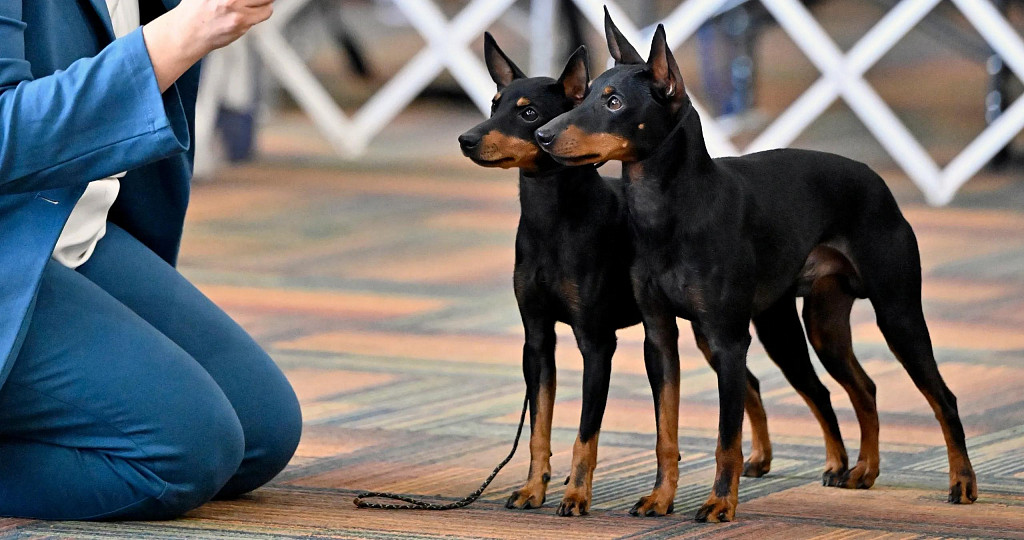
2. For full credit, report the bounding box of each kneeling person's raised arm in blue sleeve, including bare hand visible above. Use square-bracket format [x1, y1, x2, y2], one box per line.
[0, 0, 271, 195]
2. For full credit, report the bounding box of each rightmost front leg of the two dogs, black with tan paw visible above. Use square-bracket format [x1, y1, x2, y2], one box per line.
[694, 320, 751, 522]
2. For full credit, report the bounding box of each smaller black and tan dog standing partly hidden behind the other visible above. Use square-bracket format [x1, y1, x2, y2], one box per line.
[459, 34, 846, 515]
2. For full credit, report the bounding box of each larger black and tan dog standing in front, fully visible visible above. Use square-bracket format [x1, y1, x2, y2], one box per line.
[536, 11, 978, 521]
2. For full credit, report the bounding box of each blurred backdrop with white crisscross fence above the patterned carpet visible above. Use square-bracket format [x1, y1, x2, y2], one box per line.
[193, 0, 1024, 205]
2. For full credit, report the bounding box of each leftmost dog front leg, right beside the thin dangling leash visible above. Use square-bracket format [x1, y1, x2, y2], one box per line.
[505, 314, 555, 508]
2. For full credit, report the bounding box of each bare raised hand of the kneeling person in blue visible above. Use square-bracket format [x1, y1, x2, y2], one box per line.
[142, 0, 273, 92]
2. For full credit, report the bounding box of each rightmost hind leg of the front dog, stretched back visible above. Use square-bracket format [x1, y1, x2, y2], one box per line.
[858, 221, 978, 504]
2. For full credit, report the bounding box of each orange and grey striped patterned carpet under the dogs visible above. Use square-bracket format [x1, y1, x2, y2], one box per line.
[0, 158, 1024, 539]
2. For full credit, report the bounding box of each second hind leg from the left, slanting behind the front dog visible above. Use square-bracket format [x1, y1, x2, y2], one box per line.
[744, 295, 849, 485]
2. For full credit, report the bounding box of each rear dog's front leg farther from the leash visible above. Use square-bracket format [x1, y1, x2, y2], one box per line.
[558, 329, 615, 516]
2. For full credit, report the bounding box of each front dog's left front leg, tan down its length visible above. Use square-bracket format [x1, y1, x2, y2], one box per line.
[630, 311, 679, 515]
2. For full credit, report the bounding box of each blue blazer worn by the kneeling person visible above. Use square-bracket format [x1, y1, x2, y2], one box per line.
[0, 0, 199, 385]
